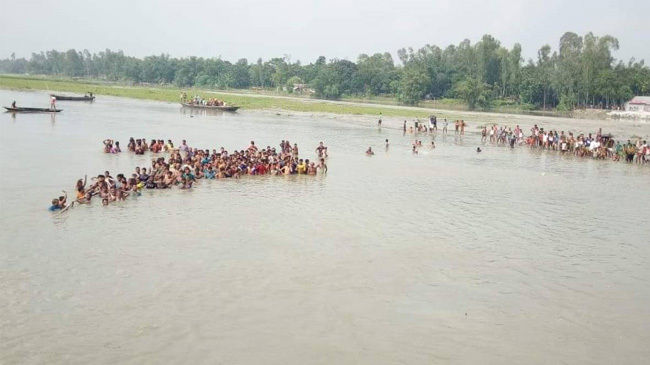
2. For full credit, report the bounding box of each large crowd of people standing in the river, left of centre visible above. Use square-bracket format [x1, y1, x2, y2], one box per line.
[50, 138, 328, 211]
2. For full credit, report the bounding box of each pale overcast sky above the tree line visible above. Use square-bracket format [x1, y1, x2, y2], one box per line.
[0, 0, 650, 63]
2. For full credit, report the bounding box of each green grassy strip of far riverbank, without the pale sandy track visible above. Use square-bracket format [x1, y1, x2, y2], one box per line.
[0, 75, 440, 118]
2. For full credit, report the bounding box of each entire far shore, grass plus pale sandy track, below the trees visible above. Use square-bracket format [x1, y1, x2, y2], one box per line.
[0, 75, 608, 120]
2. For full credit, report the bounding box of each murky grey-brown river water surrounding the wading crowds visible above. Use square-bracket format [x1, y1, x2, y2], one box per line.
[0, 91, 650, 364]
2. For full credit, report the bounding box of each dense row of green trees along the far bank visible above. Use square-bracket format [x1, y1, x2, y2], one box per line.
[0, 32, 650, 110]
